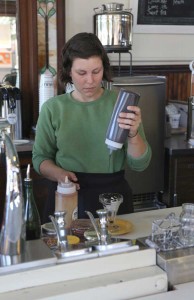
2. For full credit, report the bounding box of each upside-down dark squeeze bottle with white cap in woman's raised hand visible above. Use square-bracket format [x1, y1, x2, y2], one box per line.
[105, 89, 140, 154]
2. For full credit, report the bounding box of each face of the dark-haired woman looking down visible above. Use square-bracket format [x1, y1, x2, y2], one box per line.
[70, 56, 104, 101]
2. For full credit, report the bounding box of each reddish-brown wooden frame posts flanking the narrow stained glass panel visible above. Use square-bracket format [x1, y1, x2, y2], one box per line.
[17, 0, 65, 138]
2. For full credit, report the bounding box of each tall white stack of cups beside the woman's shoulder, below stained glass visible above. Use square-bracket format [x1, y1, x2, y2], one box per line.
[39, 69, 54, 112]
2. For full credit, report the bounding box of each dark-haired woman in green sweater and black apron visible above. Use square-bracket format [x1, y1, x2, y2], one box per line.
[33, 32, 151, 221]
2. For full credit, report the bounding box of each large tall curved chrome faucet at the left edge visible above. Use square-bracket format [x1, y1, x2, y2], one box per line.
[0, 132, 25, 258]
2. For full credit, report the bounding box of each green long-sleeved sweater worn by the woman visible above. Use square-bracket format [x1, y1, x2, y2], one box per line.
[33, 90, 151, 173]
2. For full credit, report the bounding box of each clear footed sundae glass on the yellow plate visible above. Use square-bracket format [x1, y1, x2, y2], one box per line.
[99, 193, 123, 232]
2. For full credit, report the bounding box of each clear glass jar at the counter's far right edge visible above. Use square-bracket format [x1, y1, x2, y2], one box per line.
[180, 203, 194, 247]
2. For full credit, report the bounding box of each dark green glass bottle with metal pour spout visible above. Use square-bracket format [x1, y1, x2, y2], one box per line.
[24, 164, 41, 241]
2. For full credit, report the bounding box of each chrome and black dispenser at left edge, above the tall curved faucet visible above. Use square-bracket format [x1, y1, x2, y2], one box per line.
[0, 83, 22, 140]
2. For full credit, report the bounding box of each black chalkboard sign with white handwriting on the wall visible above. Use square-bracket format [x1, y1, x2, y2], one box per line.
[137, 0, 194, 25]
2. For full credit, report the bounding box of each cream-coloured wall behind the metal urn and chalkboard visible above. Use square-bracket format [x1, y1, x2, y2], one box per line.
[66, 0, 194, 65]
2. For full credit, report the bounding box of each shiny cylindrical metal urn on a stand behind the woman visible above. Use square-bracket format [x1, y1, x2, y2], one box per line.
[94, 2, 133, 52]
